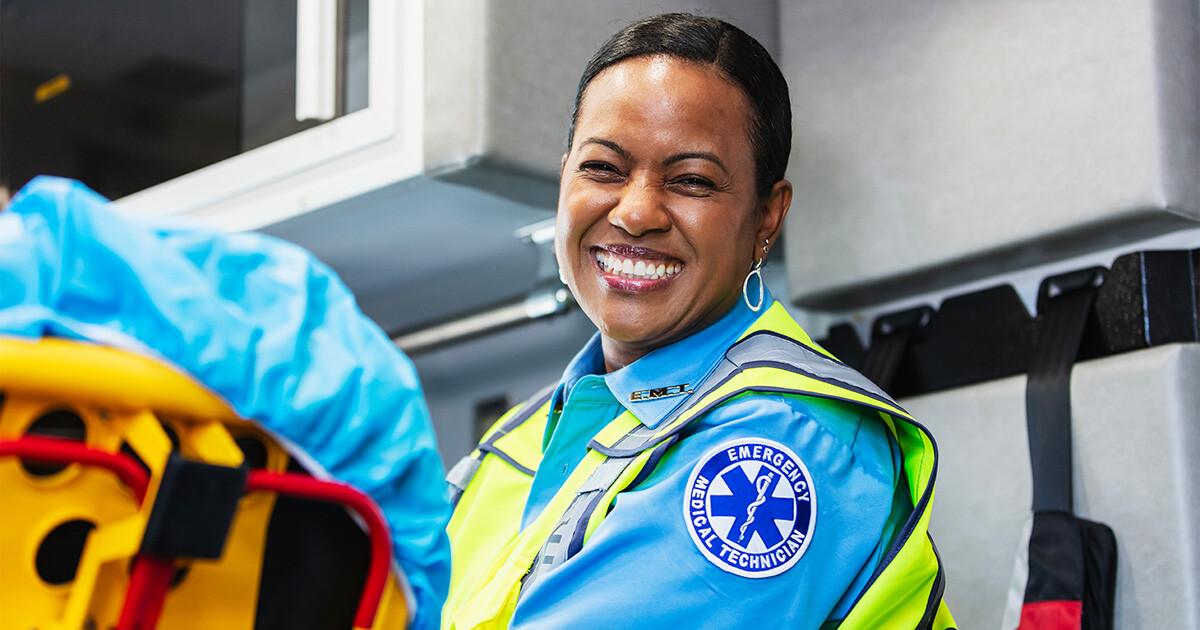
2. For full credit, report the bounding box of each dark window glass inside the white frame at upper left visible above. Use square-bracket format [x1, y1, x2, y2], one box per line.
[0, 0, 368, 198]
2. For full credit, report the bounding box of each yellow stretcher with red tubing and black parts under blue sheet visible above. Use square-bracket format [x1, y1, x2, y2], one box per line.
[0, 337, 408, 630]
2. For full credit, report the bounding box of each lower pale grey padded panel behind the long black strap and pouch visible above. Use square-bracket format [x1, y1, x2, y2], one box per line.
[900, 343, 1200, 630]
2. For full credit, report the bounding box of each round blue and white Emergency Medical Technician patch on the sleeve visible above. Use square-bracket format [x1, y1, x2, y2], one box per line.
[683, 438, 817, 577]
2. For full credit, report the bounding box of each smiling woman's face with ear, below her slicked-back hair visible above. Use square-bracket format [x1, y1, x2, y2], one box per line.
[554, 56, 791, 371]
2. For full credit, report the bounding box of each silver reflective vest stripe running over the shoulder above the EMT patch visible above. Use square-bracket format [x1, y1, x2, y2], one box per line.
[521, 331, 902, 595]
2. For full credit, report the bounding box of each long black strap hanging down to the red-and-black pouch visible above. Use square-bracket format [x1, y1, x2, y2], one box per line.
[1025, 268, 1104, 514]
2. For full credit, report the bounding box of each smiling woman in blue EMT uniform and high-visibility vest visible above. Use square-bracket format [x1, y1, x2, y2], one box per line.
[443, 14, 952, 629]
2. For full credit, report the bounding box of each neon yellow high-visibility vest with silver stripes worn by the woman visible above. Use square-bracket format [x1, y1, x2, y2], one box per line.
[442, 302, 954, 630]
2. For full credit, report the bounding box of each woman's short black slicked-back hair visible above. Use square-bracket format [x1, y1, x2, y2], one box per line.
[566, 13, 792, 197]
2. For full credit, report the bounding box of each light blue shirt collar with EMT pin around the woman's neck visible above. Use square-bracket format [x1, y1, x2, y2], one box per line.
[554, 292, 773, 428]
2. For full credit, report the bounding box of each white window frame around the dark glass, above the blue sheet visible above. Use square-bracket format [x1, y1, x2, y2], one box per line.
[114, 0, 425, 230]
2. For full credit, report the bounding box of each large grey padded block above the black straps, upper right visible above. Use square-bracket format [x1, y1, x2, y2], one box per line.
[780, 0, 1200, 310]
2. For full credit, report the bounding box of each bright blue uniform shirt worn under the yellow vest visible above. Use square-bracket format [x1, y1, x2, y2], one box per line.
[512, 296, 907, 630]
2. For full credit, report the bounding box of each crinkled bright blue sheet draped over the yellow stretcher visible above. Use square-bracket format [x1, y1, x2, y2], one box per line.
[0, 176, 450, 629]
